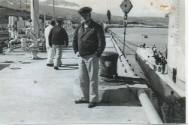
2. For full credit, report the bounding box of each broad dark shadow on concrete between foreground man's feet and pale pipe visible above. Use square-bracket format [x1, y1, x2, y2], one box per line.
[99, 88, 141, 106]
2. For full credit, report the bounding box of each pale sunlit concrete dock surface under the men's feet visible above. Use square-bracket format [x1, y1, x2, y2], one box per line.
[0, 40, 149, 125]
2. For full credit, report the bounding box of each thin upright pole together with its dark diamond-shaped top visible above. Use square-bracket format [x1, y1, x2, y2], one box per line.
[120, 0, 133, 54]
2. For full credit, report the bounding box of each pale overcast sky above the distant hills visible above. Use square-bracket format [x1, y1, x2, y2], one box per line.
[46, 0, 168, 17]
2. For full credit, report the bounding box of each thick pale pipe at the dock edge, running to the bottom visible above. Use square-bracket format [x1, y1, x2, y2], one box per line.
[137, 89, 163, 124]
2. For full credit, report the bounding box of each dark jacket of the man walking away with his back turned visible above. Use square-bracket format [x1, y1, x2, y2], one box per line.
[49, 26, 68, 46]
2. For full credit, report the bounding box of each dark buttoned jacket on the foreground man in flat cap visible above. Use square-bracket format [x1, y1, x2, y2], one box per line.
[73, 20, 106, 57]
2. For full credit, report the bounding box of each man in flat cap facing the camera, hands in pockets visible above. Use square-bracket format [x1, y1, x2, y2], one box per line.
[73, 7, 106, 108]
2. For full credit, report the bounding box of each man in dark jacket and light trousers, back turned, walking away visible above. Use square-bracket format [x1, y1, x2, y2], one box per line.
[49, 19, 68, 70]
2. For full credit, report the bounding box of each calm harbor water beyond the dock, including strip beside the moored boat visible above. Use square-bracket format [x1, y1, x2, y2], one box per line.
[111, 27, 168, 78]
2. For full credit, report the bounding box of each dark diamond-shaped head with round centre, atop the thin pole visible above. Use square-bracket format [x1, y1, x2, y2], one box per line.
[120, 0, 133, 14]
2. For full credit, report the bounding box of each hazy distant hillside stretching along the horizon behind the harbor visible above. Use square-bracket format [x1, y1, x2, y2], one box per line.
[0, 3, 168, 26]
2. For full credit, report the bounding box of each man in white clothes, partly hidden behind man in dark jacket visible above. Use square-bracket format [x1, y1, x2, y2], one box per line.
[44, 20, 56, 66]
